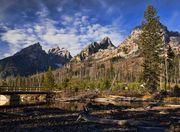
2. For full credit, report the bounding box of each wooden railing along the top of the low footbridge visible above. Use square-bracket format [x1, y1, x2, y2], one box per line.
[0, 86, 50, 92]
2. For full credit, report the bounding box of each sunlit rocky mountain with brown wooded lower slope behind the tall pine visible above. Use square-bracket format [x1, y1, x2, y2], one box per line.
[55, 25, 180, 82]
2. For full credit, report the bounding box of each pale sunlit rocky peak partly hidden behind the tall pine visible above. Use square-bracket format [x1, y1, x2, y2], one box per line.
[117, 25, 180, 57]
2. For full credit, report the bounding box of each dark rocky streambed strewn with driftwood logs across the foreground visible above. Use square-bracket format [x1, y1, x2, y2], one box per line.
[0, 91, 180, 132]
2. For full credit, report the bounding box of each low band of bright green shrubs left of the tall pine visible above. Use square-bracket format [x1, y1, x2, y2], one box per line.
[58, 78, 145, 94]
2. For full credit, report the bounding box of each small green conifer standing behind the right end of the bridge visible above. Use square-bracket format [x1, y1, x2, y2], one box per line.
[43, 67, 55, 89]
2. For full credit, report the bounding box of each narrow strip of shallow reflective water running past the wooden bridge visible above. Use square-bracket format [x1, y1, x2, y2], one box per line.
[0, 99, 149, 112]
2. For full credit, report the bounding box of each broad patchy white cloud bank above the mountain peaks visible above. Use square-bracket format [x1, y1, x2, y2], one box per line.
[1, 11, 123, 56]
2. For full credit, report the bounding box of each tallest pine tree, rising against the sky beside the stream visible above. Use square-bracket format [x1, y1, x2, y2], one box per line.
[139, 5, 164, 92]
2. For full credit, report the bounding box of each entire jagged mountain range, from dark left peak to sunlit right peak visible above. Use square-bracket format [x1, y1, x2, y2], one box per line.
[0, 25, 180, 78]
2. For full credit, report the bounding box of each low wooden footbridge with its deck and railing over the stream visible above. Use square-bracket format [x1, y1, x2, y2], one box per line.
[0, 86, 52, 95]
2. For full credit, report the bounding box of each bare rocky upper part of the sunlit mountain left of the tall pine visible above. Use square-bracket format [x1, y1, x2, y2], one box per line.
[71, 28, 141, 62]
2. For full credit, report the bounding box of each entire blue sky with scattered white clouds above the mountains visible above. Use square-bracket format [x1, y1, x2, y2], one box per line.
[0, 0, 180, 58]
